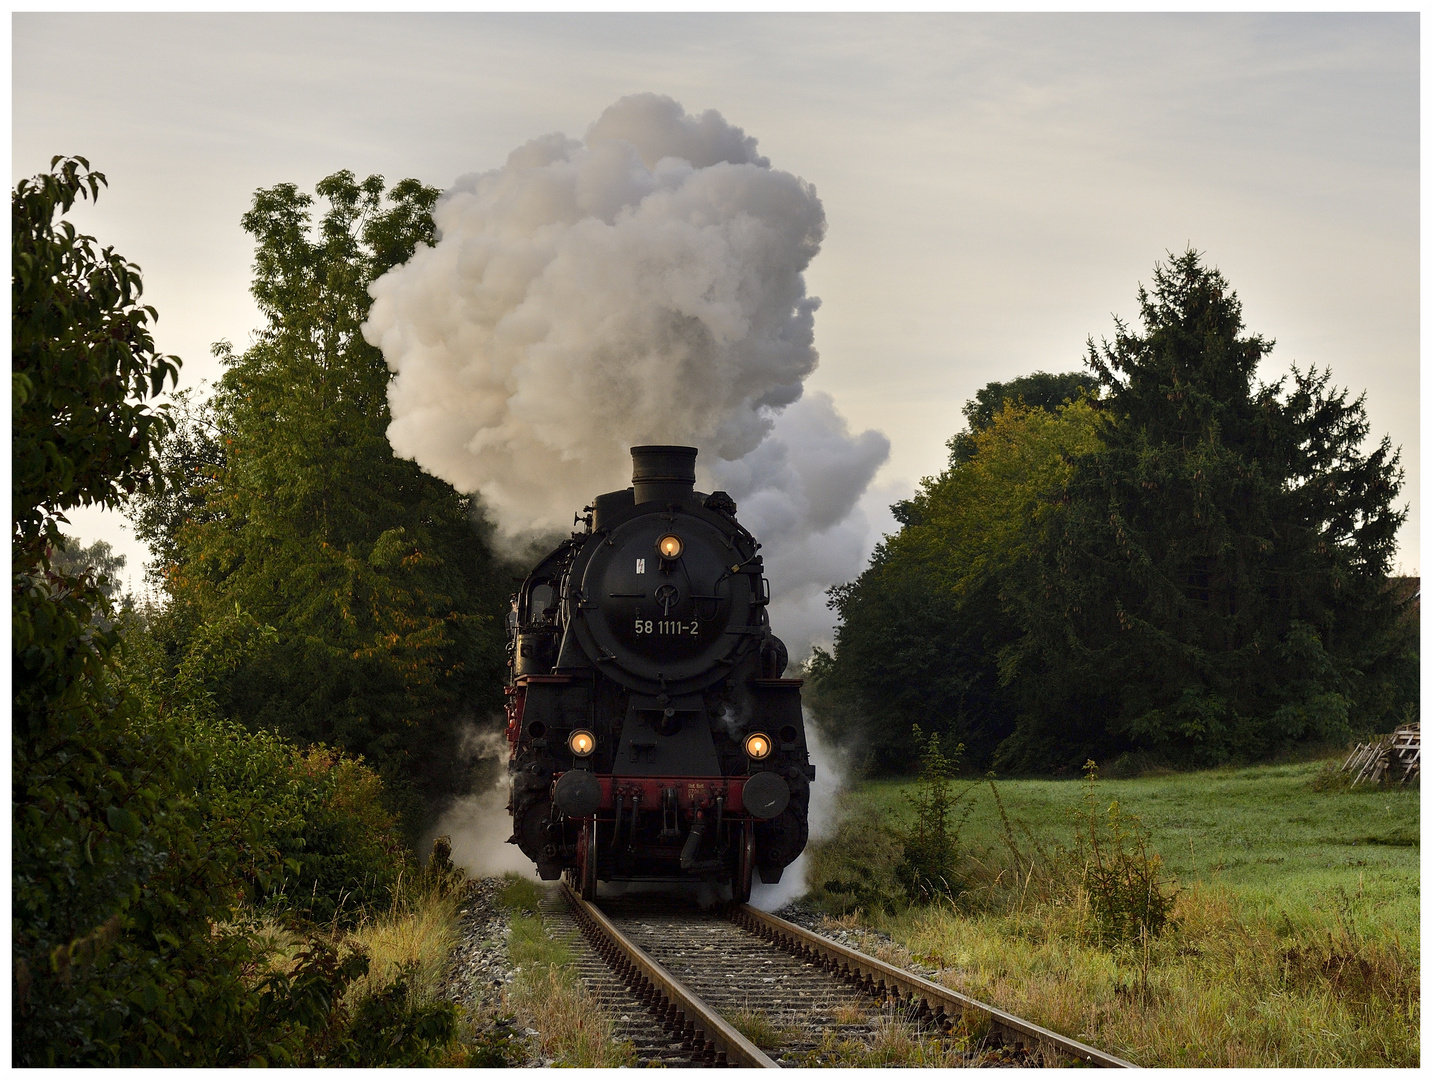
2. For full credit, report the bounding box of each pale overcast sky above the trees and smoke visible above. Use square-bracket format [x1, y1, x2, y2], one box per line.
[11, 14, 1421, 598]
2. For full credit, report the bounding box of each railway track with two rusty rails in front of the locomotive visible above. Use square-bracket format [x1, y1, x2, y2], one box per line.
[543, 884, 1133, 1069]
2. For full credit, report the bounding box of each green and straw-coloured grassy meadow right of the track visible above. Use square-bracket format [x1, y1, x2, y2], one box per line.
[808, 762, 1421, 1067]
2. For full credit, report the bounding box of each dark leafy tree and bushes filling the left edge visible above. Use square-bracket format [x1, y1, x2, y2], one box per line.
[11, 159, 454, 1067]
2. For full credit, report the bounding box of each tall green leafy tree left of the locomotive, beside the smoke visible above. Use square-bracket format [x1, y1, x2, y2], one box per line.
[136, 172, 510, 811]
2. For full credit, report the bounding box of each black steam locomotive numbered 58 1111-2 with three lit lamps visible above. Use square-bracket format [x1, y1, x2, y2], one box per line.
[505, 445, 815, 902]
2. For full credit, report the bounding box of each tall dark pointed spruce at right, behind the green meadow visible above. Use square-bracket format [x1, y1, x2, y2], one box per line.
[1001, 251, 1411, 768]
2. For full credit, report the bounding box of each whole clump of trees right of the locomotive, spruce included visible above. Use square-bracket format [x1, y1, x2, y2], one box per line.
[812, 251, 1418, 772]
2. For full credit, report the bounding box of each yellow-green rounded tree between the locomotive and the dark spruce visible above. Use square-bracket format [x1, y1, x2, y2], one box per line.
[812, 400, 1095, 772]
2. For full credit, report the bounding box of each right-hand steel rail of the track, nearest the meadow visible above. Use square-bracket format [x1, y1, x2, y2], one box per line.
[732, 904, 1138, 1069]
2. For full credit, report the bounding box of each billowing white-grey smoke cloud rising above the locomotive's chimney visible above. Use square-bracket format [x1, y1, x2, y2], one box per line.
[364, 95, 889, 657]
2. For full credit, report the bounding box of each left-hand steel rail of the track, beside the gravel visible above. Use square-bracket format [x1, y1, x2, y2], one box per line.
[561, 881, 780, 1069]
